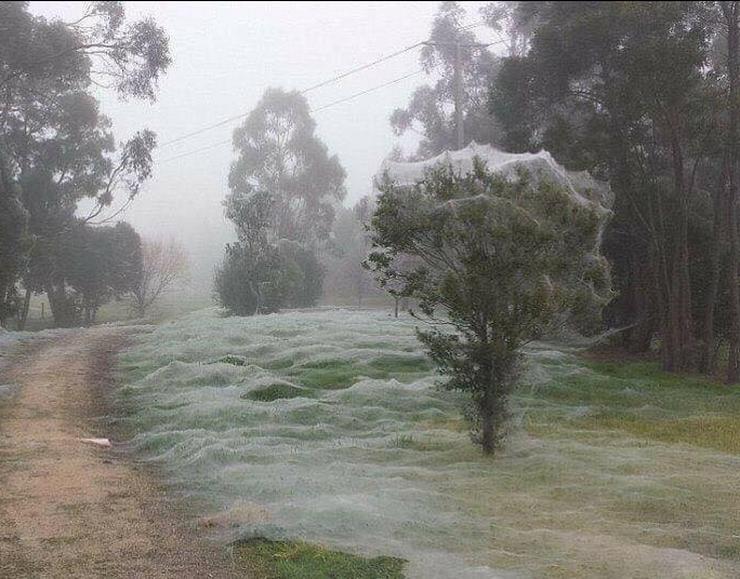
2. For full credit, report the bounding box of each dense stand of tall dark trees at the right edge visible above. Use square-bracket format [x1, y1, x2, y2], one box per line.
[491, 2, 740, 381]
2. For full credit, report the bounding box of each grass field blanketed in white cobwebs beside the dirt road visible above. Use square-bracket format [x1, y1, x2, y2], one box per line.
[119, 310, 740, 578]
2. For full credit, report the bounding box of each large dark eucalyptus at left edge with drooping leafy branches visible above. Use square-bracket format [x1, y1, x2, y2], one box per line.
[0, 2, 170, 325]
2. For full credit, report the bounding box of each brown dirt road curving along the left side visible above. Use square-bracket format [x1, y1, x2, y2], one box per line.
[0, 327, 235, 578]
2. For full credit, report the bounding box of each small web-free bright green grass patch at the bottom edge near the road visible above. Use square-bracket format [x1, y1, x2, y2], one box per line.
[233, 539, 405, 579]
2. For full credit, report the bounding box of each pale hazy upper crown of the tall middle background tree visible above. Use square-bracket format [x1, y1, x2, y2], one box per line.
[226, 89, 345, 244]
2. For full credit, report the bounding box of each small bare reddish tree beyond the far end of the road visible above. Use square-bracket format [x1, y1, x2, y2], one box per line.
[132, 239, 189, 316]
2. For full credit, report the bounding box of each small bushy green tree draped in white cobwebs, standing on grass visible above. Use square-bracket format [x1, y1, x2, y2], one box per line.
[368, 160, 610, 453]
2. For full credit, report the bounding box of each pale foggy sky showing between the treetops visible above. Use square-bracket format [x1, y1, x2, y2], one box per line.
[30, 2, 498, 285]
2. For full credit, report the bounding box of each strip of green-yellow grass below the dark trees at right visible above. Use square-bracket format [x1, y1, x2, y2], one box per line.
[528, 361, 740, 454]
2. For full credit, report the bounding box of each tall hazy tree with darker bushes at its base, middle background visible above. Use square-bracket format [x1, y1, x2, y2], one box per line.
[215, 89, 345, 315]
